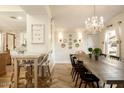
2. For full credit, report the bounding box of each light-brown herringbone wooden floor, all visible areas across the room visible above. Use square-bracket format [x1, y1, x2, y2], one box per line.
[0, 64, 118, 88]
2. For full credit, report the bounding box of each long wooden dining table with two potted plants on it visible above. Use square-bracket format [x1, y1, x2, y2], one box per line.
[77, 55, 124, 84]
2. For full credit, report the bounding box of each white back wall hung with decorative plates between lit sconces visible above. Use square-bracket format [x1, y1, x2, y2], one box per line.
[54, 30, 98, 63]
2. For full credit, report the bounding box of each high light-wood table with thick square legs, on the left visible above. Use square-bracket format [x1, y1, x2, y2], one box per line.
[11, 53, 41, 88]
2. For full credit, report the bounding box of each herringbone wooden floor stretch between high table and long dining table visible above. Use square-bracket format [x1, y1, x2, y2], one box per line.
[50, 64, 74, 88]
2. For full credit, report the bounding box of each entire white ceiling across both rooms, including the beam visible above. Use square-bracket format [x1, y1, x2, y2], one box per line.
[0, 5, 124, 31]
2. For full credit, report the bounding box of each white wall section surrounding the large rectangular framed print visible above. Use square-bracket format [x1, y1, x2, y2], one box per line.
[27, 14, 50, 53]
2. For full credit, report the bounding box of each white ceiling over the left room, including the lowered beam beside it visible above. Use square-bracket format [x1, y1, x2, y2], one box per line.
[0, 5, 48, 32]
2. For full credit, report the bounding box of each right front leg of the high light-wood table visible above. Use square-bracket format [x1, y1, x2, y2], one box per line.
[34, 59, 38, 88]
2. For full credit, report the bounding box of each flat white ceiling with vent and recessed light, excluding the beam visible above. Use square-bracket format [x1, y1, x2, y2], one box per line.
[0, 12, 26, 32]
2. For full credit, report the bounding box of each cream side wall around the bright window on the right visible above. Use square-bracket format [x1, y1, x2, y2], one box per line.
[99, 13, 124, 59]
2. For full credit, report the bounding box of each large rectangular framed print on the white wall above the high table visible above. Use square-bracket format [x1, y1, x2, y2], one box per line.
[31, 24, 45, 44]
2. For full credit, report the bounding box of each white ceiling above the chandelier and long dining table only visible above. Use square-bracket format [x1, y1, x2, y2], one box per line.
[50, 5, 124, 30]
